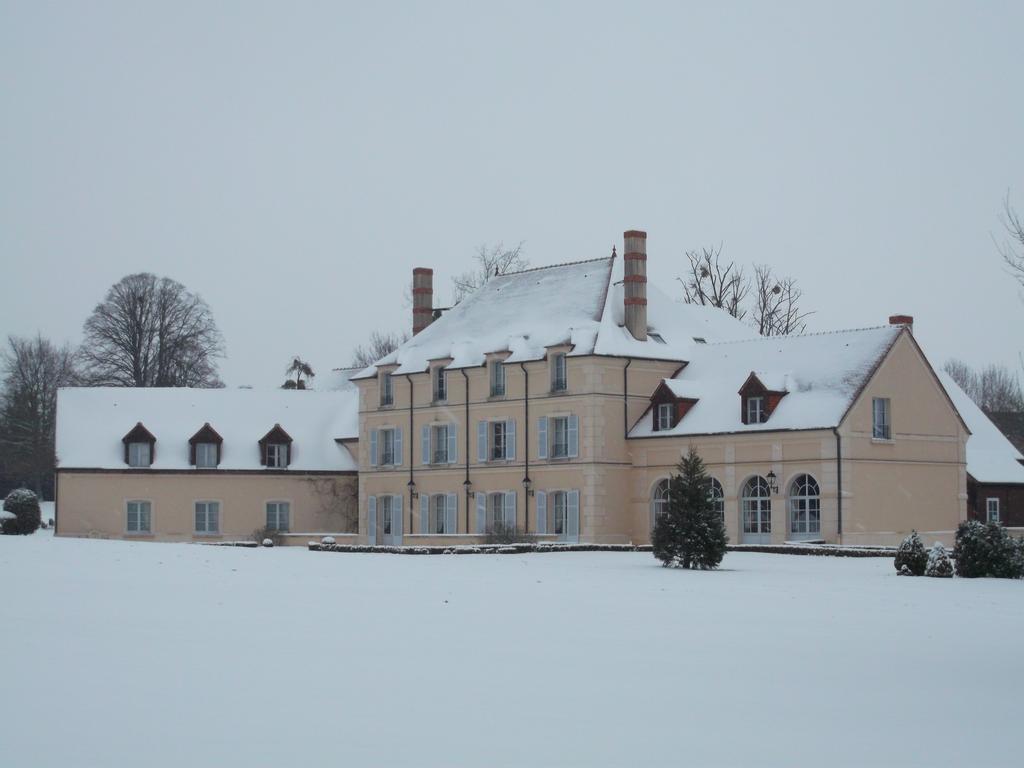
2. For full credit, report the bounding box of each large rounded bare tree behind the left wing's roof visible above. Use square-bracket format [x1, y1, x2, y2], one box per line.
[80, 272, 224, 387]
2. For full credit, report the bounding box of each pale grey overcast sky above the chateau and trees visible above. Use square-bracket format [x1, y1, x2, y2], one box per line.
[0, 0, 1024, 386]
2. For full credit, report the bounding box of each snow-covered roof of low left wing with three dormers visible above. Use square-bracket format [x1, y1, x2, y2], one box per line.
[56, 387, 358, 471]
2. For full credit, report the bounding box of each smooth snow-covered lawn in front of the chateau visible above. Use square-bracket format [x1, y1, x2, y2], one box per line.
[0, 531, 1024, 768]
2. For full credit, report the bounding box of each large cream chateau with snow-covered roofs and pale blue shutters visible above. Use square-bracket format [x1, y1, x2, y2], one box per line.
[57, 230, 1024, 546]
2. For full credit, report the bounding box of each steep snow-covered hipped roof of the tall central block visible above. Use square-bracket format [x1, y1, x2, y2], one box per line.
[353, 257, 754, 379]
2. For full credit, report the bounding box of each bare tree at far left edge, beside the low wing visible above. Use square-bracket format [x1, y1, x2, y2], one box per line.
[0, 335, 78, 498]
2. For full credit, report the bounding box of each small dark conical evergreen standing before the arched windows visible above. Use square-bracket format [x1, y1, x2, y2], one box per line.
[651, 446, 729, 570]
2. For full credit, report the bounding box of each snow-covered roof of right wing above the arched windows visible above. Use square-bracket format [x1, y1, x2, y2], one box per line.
[630, 326, 901, 437]
